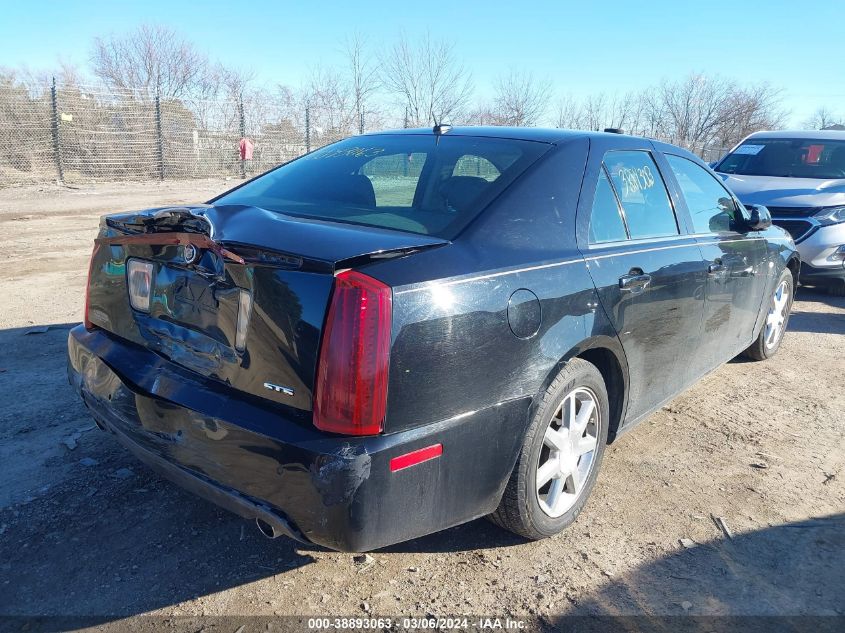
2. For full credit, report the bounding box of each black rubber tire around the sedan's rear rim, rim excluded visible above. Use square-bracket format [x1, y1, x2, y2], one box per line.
[489, 358, 610, 540]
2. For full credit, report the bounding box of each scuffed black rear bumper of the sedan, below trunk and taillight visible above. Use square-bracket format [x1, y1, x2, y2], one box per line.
[68, 326, 528, 551]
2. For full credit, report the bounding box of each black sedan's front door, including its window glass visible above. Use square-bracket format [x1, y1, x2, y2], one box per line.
[664, 153, 767, 374]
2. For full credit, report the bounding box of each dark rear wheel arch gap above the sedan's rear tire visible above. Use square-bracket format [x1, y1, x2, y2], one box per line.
[529, 336, 628, 444]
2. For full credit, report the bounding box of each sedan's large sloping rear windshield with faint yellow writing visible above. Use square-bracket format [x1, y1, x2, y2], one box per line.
[214, 134, 550, 239]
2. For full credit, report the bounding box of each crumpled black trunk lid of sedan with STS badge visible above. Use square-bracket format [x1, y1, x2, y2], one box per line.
[87, 205, 447, 421]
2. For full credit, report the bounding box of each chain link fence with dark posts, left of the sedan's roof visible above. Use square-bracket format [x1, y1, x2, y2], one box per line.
[0, 80, 354, 187]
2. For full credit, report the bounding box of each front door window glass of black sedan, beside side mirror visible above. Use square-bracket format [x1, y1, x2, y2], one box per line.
[666, 154, 741, 233]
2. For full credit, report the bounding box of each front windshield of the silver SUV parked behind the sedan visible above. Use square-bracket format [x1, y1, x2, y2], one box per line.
[716, 138, 845, 179]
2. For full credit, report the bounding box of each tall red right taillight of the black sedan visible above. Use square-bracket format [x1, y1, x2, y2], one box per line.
[314, 270, 393, 435]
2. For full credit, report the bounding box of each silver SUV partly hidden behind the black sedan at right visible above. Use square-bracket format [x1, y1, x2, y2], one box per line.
[713, 130, 845, 296]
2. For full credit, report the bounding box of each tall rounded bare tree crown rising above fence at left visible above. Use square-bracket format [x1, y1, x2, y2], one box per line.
[91, 25, 213, 98]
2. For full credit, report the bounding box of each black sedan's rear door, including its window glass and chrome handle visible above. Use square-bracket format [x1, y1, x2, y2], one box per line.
[578, 138, 706, 420]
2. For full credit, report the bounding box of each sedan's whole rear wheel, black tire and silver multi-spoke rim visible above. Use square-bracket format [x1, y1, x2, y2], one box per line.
[490, 358, 609, 539]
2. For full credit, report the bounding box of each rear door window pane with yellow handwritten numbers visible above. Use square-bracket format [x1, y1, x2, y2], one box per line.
[604, 151, 678, 239]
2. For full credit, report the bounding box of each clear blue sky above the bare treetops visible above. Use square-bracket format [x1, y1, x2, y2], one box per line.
[0, 0, 845, 125]
